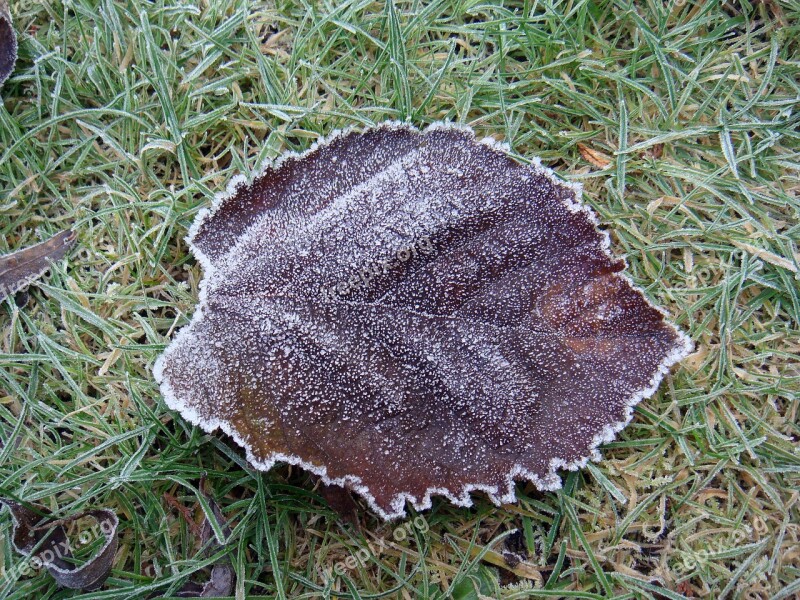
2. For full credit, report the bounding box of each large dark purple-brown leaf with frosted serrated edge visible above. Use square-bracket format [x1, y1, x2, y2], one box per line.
[155, 123, 691, 518]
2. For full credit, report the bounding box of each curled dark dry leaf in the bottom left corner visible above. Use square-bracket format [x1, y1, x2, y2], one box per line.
[0, 498, 119, 591]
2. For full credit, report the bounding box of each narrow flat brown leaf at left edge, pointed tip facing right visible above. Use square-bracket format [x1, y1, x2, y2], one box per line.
[0, 229, 75, 300]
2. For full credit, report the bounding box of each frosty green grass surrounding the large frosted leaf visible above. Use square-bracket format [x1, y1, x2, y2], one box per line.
[0, 0, 800, 600]
